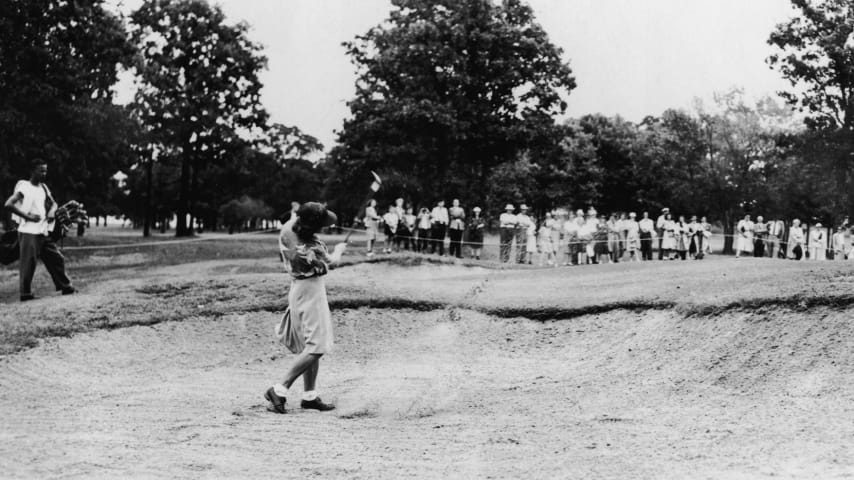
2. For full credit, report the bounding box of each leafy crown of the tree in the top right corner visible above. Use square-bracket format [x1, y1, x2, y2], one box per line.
[768, 0, 854, 131]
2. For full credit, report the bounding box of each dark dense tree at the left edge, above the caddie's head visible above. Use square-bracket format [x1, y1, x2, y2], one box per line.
[0, 0, 137, 221]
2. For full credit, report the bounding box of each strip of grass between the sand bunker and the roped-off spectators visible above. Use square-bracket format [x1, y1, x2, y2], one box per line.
[0, 226, 854, 354]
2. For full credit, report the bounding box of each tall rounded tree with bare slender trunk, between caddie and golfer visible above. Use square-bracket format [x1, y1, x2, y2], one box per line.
[131, 0, 267, 236]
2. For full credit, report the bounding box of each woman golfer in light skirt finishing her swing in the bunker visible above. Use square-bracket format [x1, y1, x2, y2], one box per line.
[264, 202, 346, 413]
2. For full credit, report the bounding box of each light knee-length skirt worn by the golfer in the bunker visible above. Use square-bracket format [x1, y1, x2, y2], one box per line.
[276, 276, 333, 353]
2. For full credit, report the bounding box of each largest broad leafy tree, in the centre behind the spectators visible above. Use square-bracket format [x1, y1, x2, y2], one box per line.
[327, 0, 575, 221]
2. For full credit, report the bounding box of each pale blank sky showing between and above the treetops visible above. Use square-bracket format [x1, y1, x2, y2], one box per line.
[110, 0, 794, 149]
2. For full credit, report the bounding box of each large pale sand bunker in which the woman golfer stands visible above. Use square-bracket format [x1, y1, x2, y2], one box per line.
[0, 306, 854, 478]
